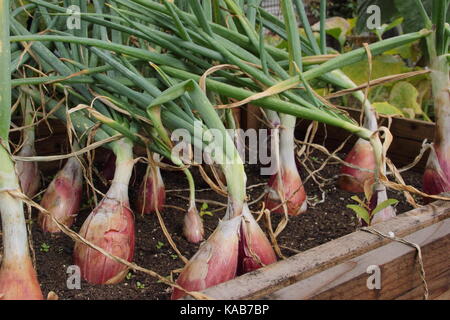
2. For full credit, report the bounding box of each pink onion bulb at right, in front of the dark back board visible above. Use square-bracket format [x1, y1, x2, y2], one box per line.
[338, 139, 376, 193]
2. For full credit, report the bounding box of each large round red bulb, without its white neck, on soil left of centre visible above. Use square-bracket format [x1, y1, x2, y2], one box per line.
[74, 194, 135, 284]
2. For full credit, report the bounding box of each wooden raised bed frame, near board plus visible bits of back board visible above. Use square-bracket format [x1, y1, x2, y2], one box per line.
[196, 109, 450, 300]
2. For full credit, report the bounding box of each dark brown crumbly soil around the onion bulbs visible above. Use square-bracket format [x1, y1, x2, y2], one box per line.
[7, 150, 421, 300]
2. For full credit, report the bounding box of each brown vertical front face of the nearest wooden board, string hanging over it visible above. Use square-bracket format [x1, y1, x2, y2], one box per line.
[264, 219, 450, 300]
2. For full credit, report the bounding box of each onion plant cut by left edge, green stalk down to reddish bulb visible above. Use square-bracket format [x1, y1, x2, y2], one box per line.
[0, 0, 43, 300]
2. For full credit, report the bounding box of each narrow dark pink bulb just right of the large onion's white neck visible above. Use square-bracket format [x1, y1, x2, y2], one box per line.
[137, 169, 166, 214]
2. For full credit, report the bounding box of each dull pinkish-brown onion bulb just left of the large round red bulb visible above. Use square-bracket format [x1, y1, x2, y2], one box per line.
[38, 158, 83, 233]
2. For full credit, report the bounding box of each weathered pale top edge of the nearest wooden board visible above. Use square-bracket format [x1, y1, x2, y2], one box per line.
[198, 201, 450, 300]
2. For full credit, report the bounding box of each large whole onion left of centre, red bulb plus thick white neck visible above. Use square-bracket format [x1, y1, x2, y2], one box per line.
[74, 139, 135, 284]
